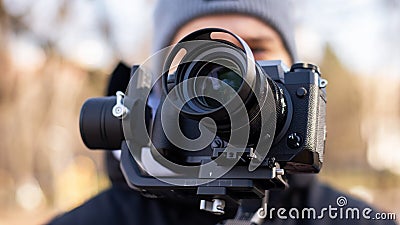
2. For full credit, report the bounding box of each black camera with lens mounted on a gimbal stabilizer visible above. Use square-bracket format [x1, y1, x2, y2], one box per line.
[80, 28, 327, 214]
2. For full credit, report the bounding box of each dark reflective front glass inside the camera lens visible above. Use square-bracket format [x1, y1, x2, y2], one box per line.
[194, 63, 243, 109]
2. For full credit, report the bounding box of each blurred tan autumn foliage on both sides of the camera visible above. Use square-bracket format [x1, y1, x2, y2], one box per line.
[0, 0, 400, 224]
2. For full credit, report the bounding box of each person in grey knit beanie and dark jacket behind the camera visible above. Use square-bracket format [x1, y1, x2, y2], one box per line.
[50, 0, 394, 225]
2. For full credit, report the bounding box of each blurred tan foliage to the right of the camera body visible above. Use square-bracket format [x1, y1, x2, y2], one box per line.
[319, 45, 400, 215]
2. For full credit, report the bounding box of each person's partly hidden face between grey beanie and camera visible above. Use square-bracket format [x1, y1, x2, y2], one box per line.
[172, 14, 292, 66]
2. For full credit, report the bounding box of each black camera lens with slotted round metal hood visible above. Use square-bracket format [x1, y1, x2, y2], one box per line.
[163, 29, 287, 146]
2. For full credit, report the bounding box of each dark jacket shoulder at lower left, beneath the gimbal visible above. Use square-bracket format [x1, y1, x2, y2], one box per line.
[49, 185, 225, 225]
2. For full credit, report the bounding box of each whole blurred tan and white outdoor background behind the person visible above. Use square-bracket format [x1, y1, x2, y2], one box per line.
[0, 0, 400, 225]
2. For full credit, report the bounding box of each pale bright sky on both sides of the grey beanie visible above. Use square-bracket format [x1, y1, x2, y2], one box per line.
[3, 0, 400, 79]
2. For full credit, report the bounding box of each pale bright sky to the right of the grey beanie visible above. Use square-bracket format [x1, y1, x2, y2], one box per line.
[295, 0, 400, 78]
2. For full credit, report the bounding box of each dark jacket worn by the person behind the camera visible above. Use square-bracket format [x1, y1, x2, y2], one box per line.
[50, 153, 395, 225]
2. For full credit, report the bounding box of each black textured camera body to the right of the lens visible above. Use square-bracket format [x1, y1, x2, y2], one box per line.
[253, 61, 327, 173]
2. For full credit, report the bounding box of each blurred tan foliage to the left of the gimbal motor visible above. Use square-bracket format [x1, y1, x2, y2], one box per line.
[0, 2, 109, 221]
